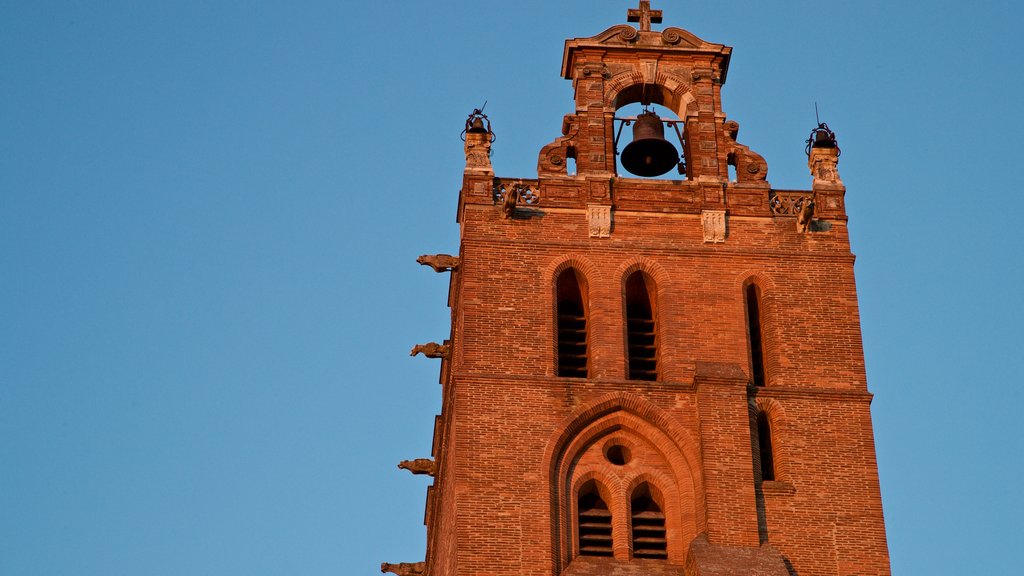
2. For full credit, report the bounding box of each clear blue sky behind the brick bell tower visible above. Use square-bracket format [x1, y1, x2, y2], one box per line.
[0, 0, 1024, 576]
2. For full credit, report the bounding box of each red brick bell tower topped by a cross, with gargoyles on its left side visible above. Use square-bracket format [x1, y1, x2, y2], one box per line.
[382, 1, 890, 576]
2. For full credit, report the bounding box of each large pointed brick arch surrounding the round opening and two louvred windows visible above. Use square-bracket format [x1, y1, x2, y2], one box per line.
[542, 392, 707, 574]
